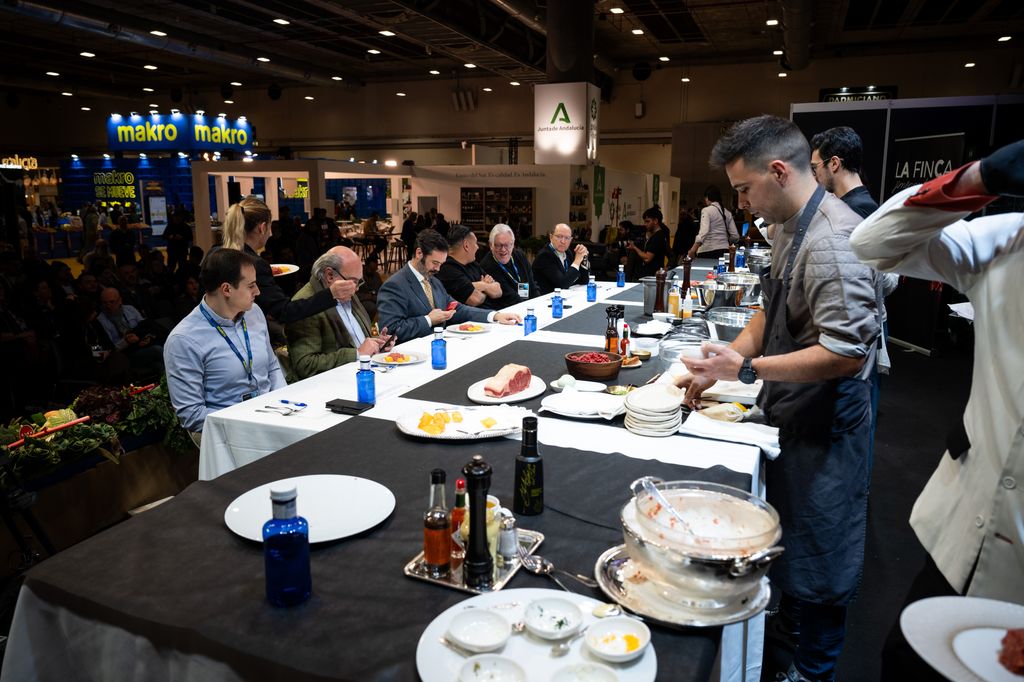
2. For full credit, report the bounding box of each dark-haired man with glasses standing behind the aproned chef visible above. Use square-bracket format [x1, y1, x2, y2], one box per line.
[811, 126, 879, 218]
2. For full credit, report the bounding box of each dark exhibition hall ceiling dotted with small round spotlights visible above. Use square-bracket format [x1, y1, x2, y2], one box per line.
[0, 0, 1024, 106]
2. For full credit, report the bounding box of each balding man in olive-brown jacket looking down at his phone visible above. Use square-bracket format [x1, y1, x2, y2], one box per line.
[285, 246, 393, 379]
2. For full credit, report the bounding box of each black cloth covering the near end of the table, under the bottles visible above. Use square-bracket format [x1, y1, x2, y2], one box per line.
[26, 417, 751, 681]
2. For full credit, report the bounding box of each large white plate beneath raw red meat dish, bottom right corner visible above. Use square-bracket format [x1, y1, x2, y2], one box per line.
[899, 597, 1024, 682]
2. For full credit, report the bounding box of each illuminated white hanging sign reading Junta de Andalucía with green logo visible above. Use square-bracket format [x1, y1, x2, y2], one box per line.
[534, 83, 601, 164]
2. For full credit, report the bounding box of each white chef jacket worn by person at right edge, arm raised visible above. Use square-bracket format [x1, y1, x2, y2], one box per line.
[850, 185, 1024, 604]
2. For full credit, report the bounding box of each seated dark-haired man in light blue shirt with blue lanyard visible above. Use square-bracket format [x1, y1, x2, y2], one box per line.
[164, 249, 285, 433]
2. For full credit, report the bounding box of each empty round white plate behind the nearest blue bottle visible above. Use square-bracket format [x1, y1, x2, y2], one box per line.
[224, 474, 394, 544]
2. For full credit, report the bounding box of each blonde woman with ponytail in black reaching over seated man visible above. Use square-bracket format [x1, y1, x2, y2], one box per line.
[222, 196, 358, 325]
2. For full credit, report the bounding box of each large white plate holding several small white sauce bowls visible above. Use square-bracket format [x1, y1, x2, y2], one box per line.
[416, 588, 657, 682]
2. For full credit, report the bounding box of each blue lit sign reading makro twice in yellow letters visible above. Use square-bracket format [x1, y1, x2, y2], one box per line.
[106, 114, 253, 152]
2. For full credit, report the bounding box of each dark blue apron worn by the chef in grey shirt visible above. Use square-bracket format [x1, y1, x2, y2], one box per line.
[758, 186, 871, 604]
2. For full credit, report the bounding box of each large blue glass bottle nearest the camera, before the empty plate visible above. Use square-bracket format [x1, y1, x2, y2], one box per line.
[263, 486, 313, 606]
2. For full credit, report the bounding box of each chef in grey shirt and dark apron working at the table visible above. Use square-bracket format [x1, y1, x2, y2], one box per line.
[677, 116, 879, 682]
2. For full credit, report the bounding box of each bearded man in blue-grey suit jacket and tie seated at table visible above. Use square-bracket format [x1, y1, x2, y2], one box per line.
[377, 229, 522, 341]
